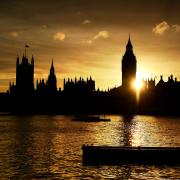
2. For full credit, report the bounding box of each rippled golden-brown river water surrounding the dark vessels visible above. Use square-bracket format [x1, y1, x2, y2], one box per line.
[0, 115, 180, 179]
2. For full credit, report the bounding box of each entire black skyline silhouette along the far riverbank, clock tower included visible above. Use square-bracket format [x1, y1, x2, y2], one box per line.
[3, 37, 180, 113]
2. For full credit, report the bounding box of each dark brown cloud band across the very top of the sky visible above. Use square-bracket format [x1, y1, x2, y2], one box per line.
[0, 0, 180, 26]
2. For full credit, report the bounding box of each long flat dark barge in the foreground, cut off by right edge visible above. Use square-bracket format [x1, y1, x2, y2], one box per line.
[82, 145, 180, 165]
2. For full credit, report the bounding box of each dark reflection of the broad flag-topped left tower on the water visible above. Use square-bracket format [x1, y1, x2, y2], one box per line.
[11, 117, 32, 174]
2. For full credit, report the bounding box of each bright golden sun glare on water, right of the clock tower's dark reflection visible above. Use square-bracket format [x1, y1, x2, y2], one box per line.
[132, 116, 180, 146]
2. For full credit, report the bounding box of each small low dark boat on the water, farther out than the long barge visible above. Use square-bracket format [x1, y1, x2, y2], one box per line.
[72, 116, 111, 122]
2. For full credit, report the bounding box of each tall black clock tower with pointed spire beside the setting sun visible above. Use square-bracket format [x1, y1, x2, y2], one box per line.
[122, 37, 136, 88]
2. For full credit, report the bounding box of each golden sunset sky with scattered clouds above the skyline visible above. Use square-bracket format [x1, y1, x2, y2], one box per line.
[0, 0, 180, 92]
